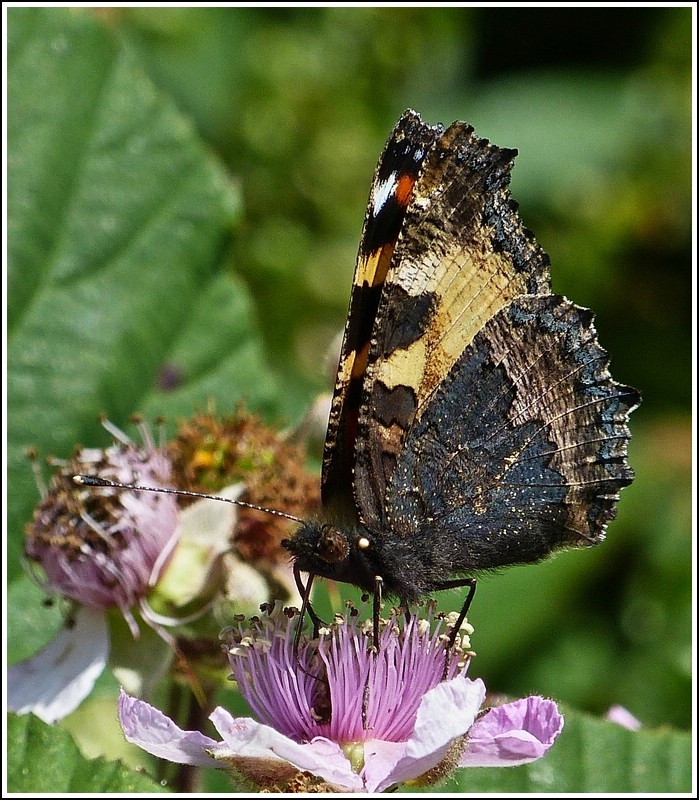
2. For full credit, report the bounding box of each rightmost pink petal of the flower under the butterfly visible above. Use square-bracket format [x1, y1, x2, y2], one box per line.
[459, 697, 563, 767]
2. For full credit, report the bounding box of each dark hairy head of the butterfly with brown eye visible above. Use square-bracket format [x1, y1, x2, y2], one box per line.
[282, 520, 376, 591]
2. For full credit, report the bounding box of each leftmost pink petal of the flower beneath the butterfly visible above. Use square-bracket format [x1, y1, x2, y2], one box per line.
[118, 691, 220, 767]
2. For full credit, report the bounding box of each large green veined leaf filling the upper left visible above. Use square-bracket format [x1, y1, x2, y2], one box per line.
[7, 8, 274, 577]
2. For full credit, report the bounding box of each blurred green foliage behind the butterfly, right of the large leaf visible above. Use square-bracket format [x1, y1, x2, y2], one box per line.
[10, 1, 692, 768]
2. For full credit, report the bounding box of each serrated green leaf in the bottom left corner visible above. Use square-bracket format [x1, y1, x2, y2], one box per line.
[7, 714, 165, 795]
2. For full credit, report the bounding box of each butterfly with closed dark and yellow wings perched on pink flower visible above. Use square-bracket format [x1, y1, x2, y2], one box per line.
[282, 110, 640, 627]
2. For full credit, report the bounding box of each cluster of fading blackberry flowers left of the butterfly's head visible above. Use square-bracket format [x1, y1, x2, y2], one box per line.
[8, 411, 314, 722]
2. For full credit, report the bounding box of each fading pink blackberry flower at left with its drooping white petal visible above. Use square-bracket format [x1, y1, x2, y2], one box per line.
[7, 422, 179, 723]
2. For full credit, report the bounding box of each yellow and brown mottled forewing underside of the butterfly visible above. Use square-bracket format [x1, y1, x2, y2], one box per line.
[354, 122, 550, 529]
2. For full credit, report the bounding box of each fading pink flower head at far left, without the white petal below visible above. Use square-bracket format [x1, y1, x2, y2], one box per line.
[25, 418, 178, 636]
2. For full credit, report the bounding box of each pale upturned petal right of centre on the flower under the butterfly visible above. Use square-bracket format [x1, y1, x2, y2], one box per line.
[362, 673, 485, 792]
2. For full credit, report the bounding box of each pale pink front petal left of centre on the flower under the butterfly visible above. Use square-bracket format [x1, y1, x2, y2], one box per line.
[210, 707, 364, 791]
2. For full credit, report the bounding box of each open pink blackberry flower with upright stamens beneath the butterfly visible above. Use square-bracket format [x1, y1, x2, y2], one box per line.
[119, 604, 563, 792]
